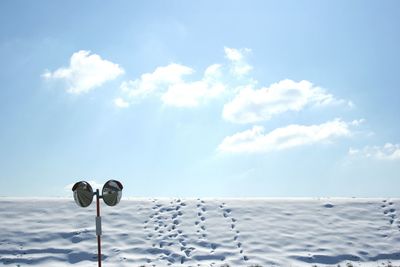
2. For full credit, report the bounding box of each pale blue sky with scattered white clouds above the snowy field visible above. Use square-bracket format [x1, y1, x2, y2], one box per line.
[0, 1, 400, 197]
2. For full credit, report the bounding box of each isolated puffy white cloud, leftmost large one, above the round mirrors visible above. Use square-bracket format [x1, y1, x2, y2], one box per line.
[42, 50, 124, 94]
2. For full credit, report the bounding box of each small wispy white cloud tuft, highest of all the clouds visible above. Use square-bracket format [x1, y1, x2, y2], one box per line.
[224, 47, 253, 76]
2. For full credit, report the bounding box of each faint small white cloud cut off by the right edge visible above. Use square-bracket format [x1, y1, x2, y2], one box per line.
[348, 143, 400, 160]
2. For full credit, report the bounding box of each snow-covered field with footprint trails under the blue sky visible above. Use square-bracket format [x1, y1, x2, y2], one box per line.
[0, 198, 400, 267]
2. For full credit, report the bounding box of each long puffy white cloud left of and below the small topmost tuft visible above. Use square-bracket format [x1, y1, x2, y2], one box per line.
[121, 64, 225, 107]
